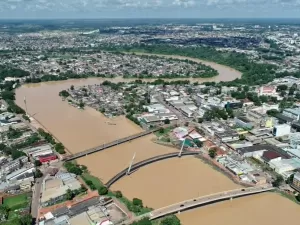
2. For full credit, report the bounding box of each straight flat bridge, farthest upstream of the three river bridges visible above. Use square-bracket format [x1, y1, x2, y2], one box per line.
[64, 127, 160, 161]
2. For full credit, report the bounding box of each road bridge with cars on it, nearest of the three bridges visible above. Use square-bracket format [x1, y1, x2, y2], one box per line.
[146, 185, 275, 220]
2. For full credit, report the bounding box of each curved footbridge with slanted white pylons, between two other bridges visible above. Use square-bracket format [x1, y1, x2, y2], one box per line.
[105, 151, 199, 188]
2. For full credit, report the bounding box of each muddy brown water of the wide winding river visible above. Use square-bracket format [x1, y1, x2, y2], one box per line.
[16, 57, 300, 225]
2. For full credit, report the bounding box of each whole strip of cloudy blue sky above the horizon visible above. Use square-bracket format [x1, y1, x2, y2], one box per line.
[0, 0, 300, 18]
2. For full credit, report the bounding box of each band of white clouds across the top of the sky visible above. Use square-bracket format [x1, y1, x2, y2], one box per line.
[0, 0, 300, 12]
